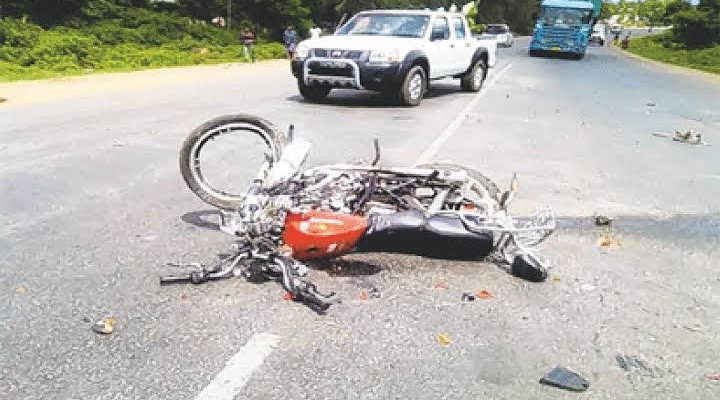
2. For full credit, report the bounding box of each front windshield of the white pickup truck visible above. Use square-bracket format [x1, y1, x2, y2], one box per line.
[337, 14, 430, 38]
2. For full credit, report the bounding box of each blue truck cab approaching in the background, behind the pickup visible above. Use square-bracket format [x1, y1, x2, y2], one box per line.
[528, 0, 599, 59]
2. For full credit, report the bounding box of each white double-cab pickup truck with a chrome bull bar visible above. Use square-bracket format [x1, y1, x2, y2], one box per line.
[292, 10, 496, 106]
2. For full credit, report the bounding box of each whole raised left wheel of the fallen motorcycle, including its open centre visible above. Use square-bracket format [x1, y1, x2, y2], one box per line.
[179, 114, 285, 210]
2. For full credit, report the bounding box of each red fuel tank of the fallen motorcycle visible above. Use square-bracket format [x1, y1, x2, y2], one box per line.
[282, 211, 367, 260]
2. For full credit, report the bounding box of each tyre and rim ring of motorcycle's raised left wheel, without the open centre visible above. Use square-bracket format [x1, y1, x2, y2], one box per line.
[179, 114, 285, 210]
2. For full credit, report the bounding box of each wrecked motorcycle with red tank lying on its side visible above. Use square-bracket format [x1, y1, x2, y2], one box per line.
[161, 115, 556, 311]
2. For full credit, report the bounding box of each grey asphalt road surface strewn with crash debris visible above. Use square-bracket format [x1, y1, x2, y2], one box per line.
[0, 40, 720, 400]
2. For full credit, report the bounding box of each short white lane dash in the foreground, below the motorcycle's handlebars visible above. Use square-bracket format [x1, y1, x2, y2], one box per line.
[195, 333, 280, 400]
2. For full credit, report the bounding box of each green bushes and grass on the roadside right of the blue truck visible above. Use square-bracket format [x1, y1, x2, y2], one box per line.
[603, 0, 720, 74]
